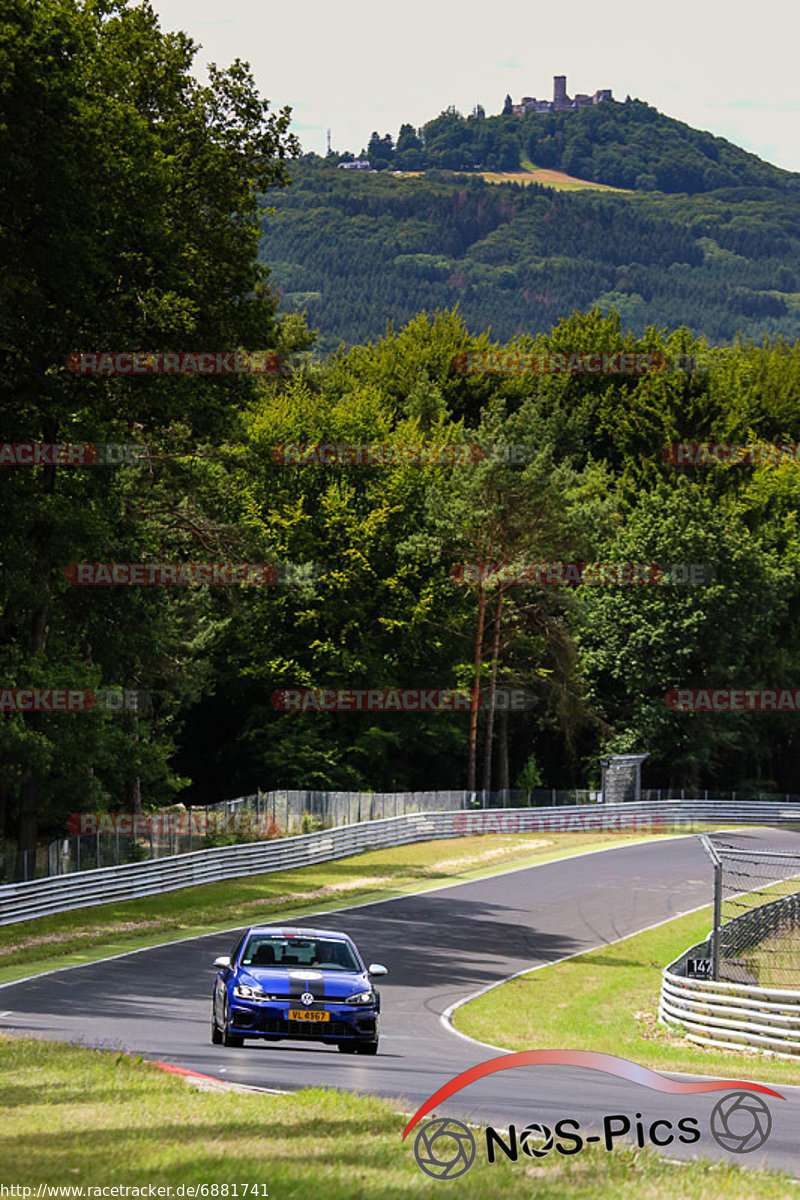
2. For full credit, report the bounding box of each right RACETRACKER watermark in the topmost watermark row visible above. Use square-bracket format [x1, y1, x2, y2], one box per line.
[452, 350, 706, 376]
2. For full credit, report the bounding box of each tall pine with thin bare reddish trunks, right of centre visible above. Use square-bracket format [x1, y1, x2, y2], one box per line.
[432, 384, 603, 791]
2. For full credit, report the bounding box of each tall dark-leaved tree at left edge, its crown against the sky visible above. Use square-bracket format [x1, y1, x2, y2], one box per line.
[0, 0, 299, 868]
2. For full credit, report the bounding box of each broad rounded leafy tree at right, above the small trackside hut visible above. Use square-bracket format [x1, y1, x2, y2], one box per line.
[577, 478, 796, 787]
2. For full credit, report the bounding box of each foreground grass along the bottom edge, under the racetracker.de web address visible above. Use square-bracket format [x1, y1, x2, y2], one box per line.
[0, 1038, 794, 1200]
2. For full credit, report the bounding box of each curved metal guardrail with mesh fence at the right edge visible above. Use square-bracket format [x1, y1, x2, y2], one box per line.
[658, 893, 800, 1058]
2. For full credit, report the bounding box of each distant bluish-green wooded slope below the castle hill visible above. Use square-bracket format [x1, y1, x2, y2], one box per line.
[259, 164, 800, 353]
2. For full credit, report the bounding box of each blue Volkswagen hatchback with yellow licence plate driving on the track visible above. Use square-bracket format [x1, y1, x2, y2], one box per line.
[211, 925, 387, 1054]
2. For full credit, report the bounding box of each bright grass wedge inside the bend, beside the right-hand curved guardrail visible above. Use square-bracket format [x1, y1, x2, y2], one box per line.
[453, 907, 800, 1084]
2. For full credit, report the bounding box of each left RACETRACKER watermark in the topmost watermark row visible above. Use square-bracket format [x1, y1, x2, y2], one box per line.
[67, 350, 281, 376]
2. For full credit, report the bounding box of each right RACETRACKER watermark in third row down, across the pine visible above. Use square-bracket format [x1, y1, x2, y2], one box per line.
[450, 563, 715, 587]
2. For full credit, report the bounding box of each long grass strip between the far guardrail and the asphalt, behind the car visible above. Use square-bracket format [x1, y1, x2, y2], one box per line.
[0, 833, 714, 983]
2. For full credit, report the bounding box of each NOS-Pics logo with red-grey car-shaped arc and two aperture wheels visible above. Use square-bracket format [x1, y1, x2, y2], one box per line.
[403, 1050, 783, 1180]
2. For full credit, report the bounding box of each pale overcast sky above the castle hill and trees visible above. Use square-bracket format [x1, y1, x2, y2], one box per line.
[152, 0, 800, 170]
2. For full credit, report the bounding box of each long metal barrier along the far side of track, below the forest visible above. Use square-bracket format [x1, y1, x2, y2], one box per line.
[0, 800, 800, 925]
